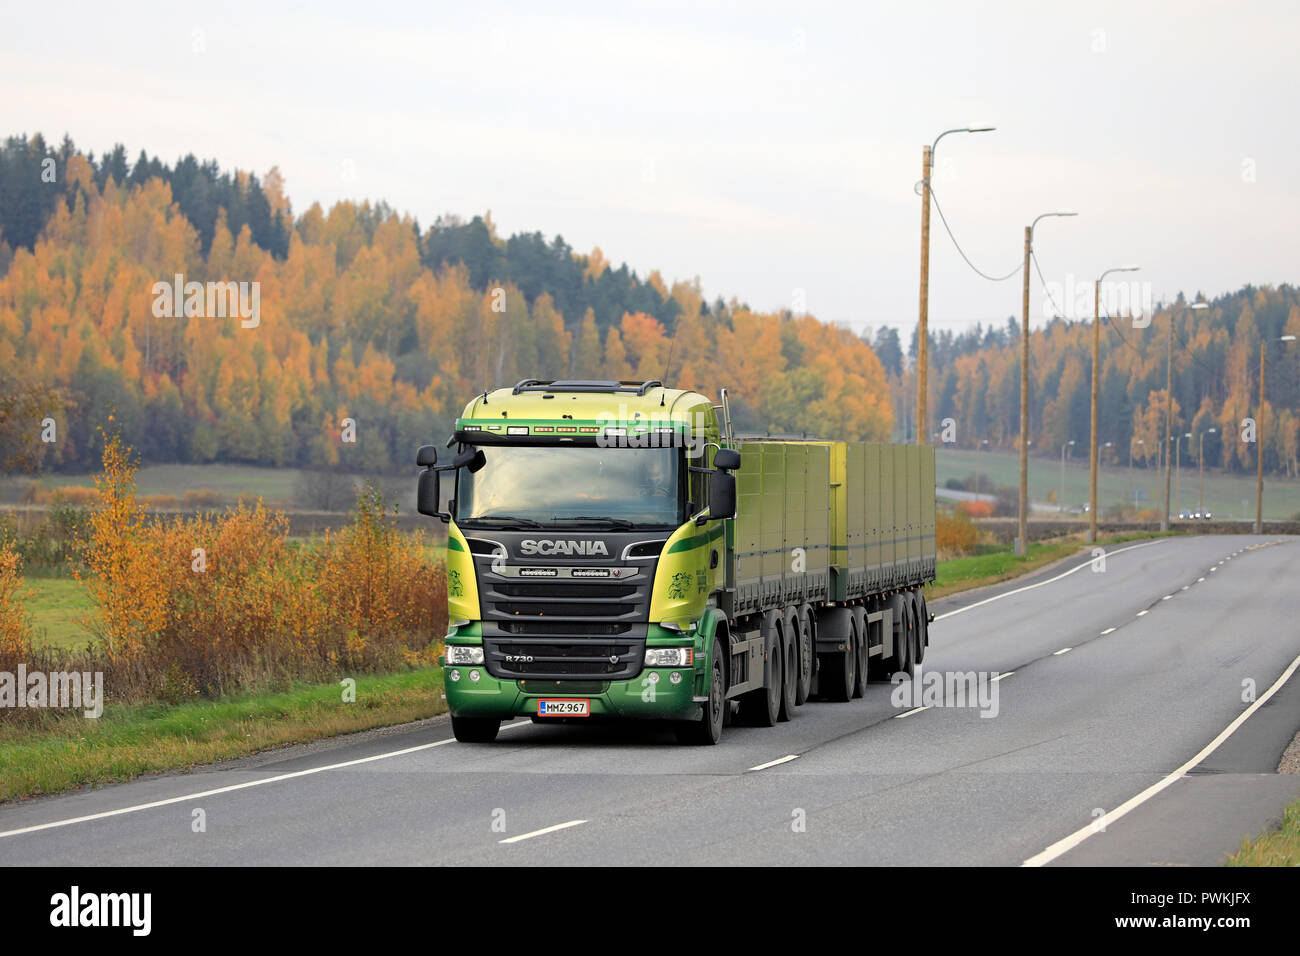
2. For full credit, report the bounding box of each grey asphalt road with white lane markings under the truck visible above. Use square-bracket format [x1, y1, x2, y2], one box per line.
[0, 536, 1300, 866]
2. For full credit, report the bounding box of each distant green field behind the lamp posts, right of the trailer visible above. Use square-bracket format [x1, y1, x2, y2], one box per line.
[935, 445, 1300, 520]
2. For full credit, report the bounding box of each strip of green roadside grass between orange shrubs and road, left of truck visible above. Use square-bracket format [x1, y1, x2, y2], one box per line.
[0, 667, 446, 800]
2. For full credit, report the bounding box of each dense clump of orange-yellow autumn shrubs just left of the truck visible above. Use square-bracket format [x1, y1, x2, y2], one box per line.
[69, 438, 446, 701]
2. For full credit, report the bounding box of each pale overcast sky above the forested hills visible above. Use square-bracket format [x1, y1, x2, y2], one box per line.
[0, 0, 1300, 341]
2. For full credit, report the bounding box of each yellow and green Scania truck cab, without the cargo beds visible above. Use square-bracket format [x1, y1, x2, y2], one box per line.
[417, 380, 738, 743]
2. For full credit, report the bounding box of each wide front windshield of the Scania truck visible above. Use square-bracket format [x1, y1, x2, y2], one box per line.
[456, 445, 685, 528]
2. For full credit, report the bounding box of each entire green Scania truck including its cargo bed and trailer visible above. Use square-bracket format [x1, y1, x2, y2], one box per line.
[416, 378, 935, 744]
